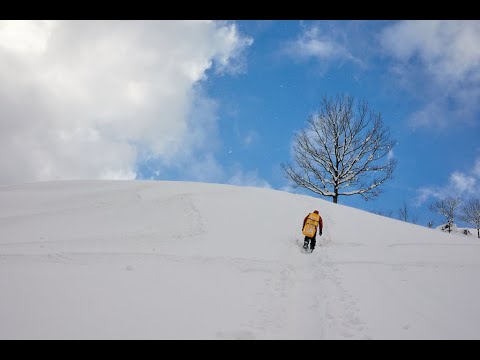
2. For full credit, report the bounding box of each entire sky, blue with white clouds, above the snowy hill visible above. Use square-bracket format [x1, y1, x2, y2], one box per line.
[0, 20, 480, 225]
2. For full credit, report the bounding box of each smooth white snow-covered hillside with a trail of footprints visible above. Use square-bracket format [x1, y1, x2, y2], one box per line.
[0, 181, 480, 339]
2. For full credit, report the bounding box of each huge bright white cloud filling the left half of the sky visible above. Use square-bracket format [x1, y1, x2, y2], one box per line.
[0, 21, 252, 184]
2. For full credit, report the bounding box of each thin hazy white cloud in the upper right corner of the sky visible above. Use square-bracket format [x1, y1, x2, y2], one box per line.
[380, 20, 480, 127]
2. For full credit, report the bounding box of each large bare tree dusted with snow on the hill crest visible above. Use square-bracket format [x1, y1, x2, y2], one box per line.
[282, 95, 396, 203]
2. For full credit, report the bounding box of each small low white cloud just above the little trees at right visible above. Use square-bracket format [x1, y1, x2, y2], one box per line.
[415, 159, 480, 206]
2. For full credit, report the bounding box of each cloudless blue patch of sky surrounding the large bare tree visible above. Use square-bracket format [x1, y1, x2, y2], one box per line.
[141, 21, 480, 224]
